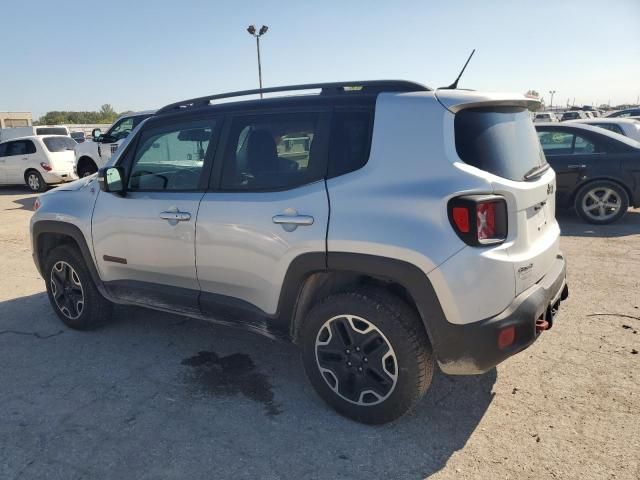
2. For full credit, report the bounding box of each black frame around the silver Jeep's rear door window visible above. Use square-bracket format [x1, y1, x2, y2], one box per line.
[207, 107, 333, 193]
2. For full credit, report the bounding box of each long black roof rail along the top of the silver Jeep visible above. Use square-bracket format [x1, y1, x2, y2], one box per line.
[156, 80, 431, 115]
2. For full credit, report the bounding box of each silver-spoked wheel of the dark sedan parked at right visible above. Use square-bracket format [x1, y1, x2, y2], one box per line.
[574, 180, 629, 225]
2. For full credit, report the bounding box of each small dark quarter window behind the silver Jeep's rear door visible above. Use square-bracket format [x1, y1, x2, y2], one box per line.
[329, 111, 373, 178]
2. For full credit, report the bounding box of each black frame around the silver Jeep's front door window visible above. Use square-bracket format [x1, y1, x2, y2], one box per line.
[116, 115, 223, 193]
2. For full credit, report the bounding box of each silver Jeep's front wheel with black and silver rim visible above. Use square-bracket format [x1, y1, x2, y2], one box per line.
[43, 245, 112, 330]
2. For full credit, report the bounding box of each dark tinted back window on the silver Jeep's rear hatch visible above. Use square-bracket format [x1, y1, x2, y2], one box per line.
[455, 107, 546, 181]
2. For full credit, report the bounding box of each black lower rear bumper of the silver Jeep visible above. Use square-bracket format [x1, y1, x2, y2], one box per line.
[434, 255, 569, 375]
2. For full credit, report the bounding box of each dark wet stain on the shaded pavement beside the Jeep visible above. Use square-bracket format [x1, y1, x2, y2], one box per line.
[181, 352, 282, 416]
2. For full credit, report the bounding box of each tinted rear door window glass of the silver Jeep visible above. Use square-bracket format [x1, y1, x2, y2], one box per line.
[221, 113, 325, 190]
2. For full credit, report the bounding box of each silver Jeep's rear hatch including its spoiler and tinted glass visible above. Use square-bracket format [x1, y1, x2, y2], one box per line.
[437, 91, 560, 294]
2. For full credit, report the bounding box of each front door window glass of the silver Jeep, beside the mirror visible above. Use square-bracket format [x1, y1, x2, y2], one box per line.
[128, 122, 214, 191]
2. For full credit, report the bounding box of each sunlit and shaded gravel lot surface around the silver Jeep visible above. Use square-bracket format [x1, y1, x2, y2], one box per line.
[0, 188, 640, 480]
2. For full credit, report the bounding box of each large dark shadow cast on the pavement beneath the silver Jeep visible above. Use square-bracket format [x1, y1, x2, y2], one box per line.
[0, 293, 497, 479]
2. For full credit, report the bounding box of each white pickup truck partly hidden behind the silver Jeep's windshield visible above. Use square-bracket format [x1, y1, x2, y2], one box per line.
[74, 111, 153, 177]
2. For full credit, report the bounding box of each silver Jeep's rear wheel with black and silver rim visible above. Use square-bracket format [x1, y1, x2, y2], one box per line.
[300, 287, 434, 424]
